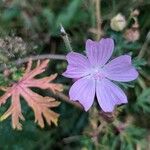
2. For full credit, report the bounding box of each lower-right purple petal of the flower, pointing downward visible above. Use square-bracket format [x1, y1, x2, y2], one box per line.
[96, 79, 127, 112]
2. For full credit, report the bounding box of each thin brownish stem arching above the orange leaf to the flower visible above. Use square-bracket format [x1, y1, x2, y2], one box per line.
[0, 54, 66, 71]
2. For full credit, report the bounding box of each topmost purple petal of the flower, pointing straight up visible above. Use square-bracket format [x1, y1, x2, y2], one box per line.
[86, 38, 114, 66]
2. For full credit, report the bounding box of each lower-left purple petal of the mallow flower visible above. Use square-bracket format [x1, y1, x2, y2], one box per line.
[69, 77, 95, 111]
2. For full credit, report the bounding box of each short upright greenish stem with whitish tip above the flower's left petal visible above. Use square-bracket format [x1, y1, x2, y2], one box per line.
[60, 24, 73, 52]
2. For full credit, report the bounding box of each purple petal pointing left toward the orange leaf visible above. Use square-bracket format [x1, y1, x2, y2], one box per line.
[63, 52, 90, 78]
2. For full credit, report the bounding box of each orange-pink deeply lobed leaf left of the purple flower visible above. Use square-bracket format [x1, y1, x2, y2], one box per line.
[0, 60, 62, 130]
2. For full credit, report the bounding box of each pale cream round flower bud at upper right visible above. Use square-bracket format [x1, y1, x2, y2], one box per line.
[110, 13, 126, 31]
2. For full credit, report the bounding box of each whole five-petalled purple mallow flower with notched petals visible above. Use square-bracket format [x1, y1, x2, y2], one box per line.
[63, 38, 138, 112]
